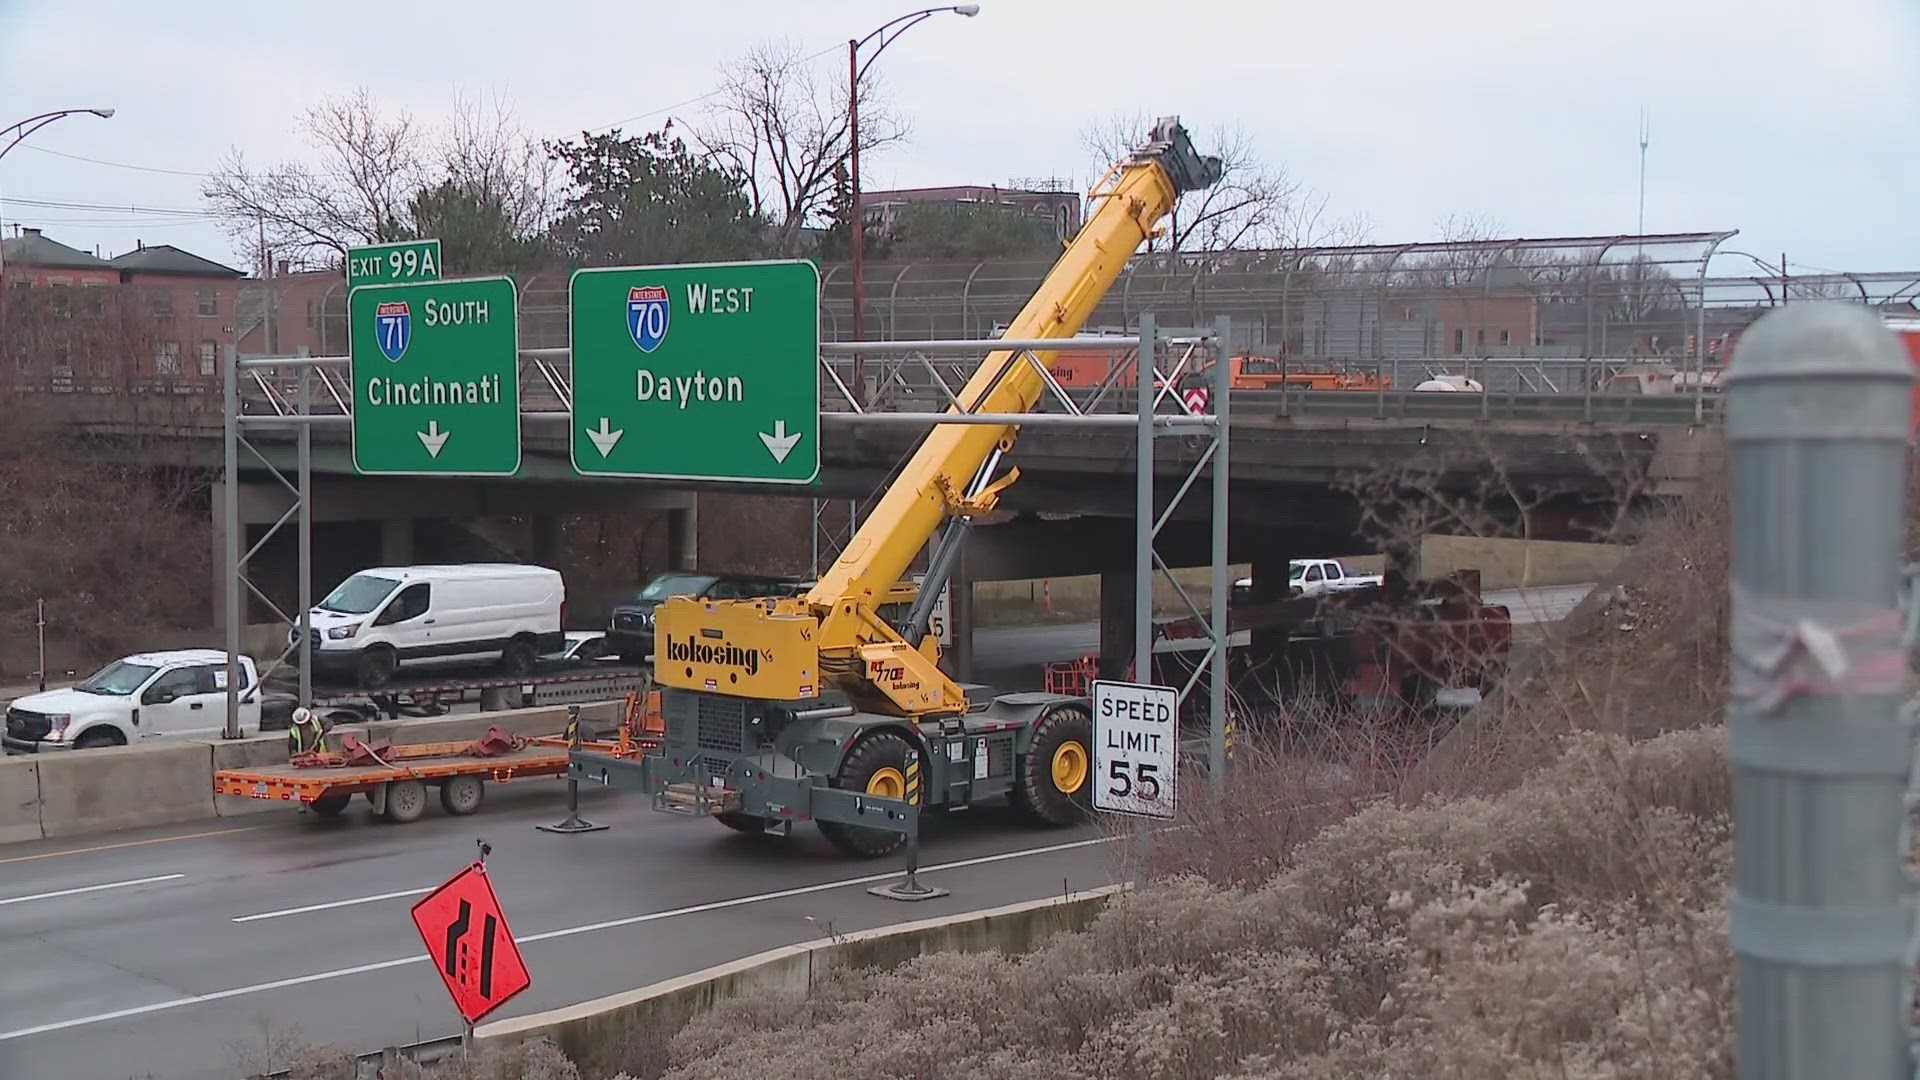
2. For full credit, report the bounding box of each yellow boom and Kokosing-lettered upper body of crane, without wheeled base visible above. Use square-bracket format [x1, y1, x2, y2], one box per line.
[655, 117, 1221, 717]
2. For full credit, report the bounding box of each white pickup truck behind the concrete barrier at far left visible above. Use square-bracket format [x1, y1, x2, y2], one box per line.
[0, 650, 261, 755]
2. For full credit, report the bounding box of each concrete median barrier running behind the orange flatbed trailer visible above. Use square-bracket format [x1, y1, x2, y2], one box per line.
[0, 701, 620, 844]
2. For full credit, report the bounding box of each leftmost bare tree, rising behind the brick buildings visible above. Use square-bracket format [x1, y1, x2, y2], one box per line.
[202, 88, 432, 265]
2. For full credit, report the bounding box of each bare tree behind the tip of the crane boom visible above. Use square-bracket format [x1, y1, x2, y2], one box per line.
[1081, 113, 1304, 256]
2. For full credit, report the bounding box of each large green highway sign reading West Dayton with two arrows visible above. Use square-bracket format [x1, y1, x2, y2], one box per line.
[568, 259, 820, 484]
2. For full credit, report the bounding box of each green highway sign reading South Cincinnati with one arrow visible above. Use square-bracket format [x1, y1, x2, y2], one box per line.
[348, 277, 520, 477]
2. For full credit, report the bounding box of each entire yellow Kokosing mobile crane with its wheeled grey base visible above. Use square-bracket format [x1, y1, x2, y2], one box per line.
[572, 117, 1221, 855]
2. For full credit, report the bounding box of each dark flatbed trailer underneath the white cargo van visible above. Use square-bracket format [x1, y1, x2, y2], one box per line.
[269, 661, 649, 724]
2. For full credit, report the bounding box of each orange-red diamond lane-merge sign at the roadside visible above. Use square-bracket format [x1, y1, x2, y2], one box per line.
[413, 846, 534, 1034]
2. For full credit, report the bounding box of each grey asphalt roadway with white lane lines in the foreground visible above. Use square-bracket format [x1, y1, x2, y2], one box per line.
[0, 780, 1121, 1080]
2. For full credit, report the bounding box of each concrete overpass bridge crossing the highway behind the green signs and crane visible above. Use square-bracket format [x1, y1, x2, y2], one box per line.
[29, 350, 1720, 659]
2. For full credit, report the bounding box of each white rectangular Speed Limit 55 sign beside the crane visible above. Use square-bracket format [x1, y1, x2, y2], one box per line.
[1092, 680, 1181, 819]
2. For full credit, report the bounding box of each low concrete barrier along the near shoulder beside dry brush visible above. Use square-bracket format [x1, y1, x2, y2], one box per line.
[474, 886, 1127, 1063]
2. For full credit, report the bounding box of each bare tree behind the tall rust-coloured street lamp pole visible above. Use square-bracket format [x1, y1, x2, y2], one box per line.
[695, 40, 906, 254]
